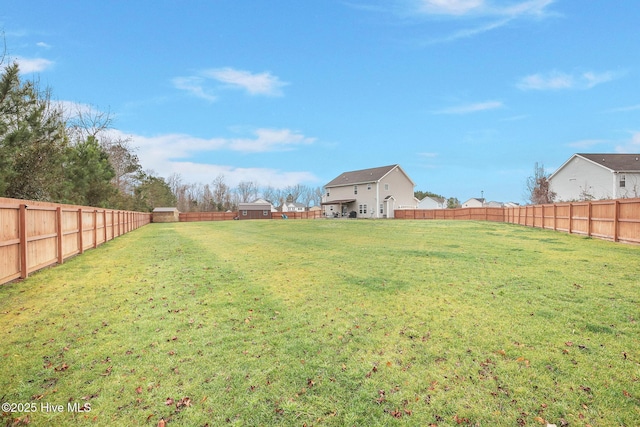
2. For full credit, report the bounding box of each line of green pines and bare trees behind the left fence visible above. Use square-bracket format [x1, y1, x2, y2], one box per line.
[0, 56, 322, 212]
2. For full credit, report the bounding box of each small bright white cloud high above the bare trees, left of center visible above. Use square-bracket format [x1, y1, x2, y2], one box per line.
[202, 67, 288, 96]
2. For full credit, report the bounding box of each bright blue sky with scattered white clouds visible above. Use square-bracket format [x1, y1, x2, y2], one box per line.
[0, 0, 640, 202]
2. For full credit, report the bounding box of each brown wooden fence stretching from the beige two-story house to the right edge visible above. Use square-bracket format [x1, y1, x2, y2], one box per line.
[395, 199, 640, 243]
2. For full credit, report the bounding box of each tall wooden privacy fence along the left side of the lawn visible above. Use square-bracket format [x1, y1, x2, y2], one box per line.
[0, 198, 151, 284]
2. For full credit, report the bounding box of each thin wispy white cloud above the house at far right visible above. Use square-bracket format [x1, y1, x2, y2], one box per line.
[516, 71, 621, 90]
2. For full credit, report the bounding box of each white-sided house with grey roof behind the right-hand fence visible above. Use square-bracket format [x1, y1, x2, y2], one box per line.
[549, 154, 640, 201]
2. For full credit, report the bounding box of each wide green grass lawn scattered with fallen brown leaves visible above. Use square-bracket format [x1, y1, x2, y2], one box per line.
[0, 220, 640, 426]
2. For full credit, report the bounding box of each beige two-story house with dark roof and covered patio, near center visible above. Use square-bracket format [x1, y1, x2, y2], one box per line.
[322, 165, 418, 218]
